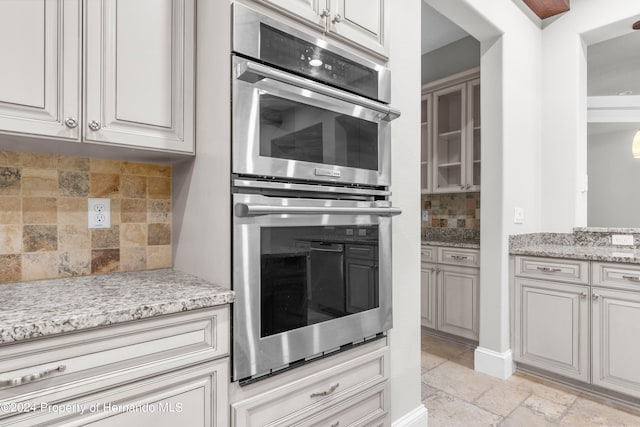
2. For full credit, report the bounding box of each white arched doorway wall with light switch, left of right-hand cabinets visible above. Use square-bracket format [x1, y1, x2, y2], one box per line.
[425, 0, 541, 376]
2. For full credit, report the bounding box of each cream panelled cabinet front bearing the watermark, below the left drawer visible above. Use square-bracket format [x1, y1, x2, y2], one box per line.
[2, 358, 229, 427]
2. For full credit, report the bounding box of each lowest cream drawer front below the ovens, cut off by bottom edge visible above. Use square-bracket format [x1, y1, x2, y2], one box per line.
[286, 381, 389, 427]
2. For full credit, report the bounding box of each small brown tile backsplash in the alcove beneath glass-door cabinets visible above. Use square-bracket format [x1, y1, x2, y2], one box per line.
[422, 193, 480, 234]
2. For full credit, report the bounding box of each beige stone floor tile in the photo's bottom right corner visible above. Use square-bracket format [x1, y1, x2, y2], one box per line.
[560, 397, 640, 427]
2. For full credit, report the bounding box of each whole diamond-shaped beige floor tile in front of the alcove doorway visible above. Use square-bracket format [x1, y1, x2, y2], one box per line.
[422, 361, 500, 402]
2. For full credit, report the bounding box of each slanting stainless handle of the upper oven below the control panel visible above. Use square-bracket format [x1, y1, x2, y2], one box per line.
[237, 61, 400, 122]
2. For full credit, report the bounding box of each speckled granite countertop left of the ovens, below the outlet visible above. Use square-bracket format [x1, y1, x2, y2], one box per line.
[0, 269, 234, 345]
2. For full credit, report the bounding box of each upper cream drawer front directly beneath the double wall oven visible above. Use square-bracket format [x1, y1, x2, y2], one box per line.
[231, 347, 389, 427]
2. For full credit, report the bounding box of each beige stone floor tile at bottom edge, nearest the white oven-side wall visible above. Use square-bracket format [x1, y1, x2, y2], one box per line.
[424, 392, 501, 427]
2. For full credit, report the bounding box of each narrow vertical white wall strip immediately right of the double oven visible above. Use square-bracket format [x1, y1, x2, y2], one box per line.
[389, 0, 428, 421]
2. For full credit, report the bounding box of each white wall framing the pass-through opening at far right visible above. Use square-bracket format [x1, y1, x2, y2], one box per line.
[542, 0, 640, 232]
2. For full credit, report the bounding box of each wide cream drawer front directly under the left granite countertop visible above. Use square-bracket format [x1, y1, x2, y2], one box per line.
[0, 306, 229, 418]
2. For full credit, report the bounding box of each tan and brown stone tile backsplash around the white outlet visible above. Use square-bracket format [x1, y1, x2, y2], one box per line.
[0, 151, 172, 283]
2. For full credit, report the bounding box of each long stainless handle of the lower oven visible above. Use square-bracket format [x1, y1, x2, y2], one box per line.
[235, 203, 402, 217]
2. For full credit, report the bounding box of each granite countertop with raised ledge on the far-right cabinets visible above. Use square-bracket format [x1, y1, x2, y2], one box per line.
[509, 231, 640, 264]
